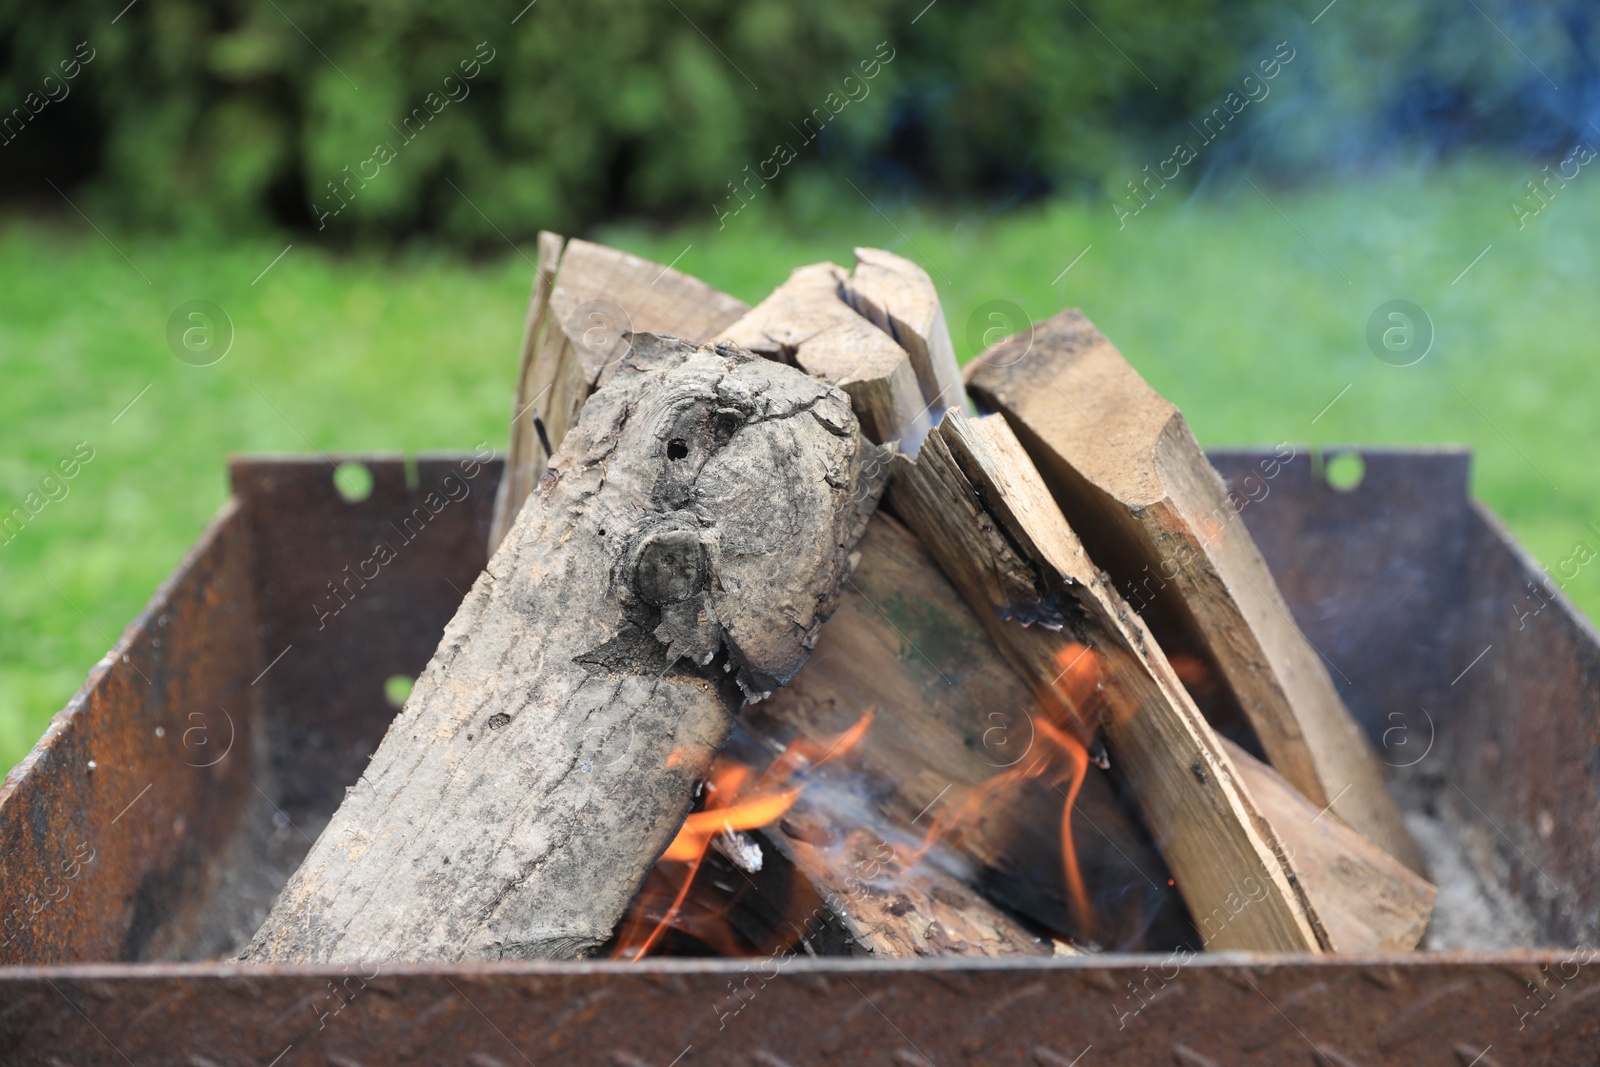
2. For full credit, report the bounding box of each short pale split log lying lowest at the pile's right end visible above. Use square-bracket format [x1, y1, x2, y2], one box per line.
[1222, 741, 1437, 952]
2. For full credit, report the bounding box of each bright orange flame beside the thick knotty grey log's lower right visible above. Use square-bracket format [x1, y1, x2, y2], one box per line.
[613, 709, 874, 960]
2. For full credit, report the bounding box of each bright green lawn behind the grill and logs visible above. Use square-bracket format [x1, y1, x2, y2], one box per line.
[0, 163, 1600, 765]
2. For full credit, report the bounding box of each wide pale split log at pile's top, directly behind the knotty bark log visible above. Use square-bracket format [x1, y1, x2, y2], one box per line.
[717, 262, 931, 454]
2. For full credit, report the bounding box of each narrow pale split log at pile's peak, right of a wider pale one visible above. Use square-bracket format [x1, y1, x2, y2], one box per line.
[843, 248, 966, 422]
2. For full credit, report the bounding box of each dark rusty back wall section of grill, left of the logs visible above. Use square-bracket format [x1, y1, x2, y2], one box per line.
[230, 453, 499, 825]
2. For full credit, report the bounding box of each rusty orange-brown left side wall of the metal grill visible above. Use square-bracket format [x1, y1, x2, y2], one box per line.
[0, 504, 261, 963]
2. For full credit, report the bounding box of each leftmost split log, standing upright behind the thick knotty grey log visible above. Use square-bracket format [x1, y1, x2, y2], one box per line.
[490, 232, 749, 555]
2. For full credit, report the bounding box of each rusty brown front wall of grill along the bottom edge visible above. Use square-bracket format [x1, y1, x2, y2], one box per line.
[0, 953, 1600, 1067]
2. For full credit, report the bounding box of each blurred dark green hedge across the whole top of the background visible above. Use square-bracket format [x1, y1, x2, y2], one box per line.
[12, 0, 1600, 235]
